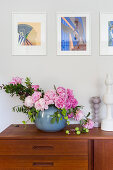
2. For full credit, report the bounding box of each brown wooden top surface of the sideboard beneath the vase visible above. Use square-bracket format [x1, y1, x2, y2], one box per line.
[0, 124, 113, 140]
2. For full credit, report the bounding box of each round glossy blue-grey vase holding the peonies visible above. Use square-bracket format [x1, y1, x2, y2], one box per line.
[35, 106, 66, 132]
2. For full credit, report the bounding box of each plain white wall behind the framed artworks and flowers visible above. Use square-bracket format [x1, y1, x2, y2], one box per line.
[0, 0, 113, 131]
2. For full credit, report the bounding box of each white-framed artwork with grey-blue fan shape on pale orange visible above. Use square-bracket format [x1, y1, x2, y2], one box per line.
[12, 13, 46, 55]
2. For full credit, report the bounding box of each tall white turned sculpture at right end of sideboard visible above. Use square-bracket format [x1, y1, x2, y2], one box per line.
[101, 74, 113, 131]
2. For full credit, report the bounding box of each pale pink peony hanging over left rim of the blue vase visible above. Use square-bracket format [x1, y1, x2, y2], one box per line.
[35, 98, 48, 111]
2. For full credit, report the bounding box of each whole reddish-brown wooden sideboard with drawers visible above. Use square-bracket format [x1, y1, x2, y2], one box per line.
[0, 125, 113, 170]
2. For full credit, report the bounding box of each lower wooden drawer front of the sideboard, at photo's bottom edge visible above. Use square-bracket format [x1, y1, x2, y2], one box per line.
[0, 156, 88, 170]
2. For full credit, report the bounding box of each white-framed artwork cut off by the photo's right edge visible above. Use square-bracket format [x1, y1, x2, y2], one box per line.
[100, 13, 113, 55]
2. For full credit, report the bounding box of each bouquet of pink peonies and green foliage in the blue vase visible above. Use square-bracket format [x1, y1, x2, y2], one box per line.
[1, 77, 94, 134]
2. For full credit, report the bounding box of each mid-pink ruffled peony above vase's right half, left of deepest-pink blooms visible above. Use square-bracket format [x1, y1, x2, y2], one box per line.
[55, 96, 65, 109]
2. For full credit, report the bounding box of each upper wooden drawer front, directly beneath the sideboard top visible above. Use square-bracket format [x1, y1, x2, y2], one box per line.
[0, 140, 88, 155]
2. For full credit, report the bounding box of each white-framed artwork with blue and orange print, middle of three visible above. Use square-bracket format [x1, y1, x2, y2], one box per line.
[57, 13, 91, 55]
